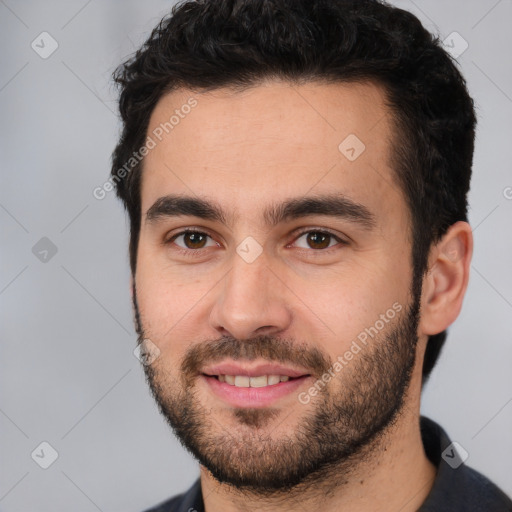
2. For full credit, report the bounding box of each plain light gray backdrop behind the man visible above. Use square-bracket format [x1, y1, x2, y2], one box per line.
[0, 0, 512, 512]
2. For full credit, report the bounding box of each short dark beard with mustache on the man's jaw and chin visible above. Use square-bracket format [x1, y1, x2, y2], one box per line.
[133, 284, 420, 497]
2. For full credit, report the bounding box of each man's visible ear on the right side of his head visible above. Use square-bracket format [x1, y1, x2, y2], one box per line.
[419, 221, 473, 335]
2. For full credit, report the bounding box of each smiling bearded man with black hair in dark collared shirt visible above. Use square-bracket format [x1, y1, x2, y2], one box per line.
[111, 0, 512, 512]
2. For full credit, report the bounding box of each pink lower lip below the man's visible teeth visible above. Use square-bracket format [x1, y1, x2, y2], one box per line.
[199, 372, 312, 408]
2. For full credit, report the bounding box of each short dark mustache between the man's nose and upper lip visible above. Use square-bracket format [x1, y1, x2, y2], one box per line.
[181, 335, 332, 378]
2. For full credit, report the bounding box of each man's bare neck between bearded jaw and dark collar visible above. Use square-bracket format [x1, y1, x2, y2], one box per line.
[201, 390, 436, 512]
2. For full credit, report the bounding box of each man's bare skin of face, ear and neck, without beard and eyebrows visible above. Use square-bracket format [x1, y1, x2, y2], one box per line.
[134, 81, 473, 512]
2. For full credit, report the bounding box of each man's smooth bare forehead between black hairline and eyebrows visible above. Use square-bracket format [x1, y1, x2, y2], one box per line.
[142, 81, 405, 230]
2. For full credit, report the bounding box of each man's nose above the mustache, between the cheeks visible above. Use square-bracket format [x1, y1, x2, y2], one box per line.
[210, 254, 292, 339]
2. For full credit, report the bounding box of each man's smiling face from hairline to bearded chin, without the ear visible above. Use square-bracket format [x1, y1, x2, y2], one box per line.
[135, 82, 418, 492]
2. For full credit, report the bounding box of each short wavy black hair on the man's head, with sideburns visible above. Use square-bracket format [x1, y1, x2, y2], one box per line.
[111, 0, 476, 382]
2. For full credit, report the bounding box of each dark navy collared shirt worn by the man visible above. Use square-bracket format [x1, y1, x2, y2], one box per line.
[142, 416, 512, 512]
